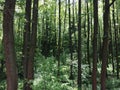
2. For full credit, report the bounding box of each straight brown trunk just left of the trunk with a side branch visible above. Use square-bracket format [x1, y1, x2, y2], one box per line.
[92, 0, 98, 90]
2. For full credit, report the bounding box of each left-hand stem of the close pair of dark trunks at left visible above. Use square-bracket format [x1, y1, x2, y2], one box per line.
[23, 0, 32, 90]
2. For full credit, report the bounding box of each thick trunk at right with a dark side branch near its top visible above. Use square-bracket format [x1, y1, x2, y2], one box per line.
[101, 0, 109, 90]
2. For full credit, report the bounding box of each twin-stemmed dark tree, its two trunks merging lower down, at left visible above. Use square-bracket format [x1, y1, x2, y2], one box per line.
[23, 0, 38, 90]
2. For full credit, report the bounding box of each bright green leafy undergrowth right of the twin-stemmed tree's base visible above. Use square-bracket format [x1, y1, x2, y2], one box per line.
[33, 54, 77, 90]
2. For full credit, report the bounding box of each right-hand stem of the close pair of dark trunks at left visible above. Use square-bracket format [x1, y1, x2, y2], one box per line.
[26, 0, 38, 90]
